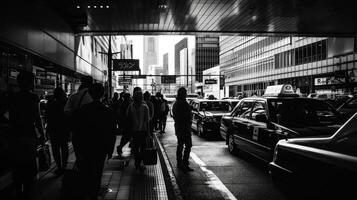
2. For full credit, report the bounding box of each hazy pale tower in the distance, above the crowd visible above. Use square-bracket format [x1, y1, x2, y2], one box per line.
[141, 36, 159, 90]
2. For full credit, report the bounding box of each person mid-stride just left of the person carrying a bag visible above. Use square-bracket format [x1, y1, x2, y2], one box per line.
[116, 93, 132, 158]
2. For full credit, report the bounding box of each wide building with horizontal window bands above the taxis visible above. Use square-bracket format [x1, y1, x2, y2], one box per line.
[220, 36, 357, 96]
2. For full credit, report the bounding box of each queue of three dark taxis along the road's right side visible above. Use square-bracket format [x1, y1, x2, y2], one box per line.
[185, 85, 357, 197]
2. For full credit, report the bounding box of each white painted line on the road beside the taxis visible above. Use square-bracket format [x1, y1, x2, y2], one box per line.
[190, 152, 237, 200]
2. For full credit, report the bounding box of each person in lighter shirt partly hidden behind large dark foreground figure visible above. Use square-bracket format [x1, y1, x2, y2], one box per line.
[64, 76, 93, 164]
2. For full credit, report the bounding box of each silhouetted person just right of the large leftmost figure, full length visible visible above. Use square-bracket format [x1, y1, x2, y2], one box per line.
[45, 87, 70, 175]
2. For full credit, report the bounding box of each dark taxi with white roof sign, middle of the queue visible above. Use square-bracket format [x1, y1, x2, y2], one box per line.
[220, 85, 343, 162]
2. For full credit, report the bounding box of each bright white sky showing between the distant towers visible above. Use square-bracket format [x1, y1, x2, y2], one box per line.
[126, 35, 195, 74]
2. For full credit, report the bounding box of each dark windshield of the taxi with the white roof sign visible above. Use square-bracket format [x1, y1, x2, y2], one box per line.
[268, 98, 338, 127]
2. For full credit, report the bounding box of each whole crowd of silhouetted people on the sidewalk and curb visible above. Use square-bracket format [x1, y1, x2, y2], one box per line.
[3, 71, 192, 199]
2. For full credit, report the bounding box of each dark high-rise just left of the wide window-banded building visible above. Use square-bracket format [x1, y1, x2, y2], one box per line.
[195, 36, 219, 82]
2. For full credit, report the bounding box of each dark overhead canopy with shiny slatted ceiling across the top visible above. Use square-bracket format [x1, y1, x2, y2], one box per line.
[45, 0, 357, 36]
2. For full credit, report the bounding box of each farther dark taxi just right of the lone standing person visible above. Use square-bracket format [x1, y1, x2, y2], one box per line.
[191, 99, 233, 136]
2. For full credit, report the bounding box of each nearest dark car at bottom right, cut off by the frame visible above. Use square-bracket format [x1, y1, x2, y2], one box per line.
[269, 114, 357, 199]
